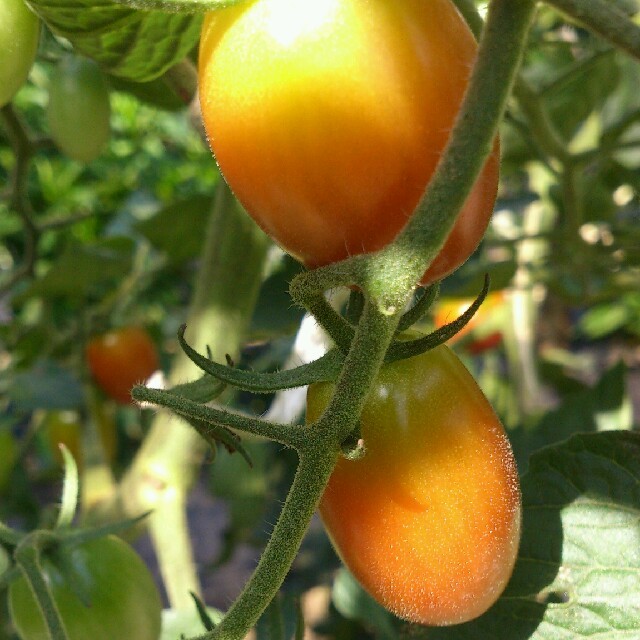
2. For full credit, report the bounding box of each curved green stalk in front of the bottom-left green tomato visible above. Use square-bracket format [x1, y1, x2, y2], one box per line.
[15, 532, 69, 640]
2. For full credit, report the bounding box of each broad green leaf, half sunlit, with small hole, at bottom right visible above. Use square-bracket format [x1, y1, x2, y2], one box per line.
[417, 431, 640, 640]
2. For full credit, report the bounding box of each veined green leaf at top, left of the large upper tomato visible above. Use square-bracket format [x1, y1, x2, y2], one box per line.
[30, 0, 202, 82]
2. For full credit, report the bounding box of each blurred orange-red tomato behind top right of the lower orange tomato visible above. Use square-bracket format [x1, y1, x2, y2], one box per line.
[433, 290, 507, 355]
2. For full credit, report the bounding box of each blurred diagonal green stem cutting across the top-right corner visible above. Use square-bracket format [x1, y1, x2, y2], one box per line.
[547, 0, 640, 59]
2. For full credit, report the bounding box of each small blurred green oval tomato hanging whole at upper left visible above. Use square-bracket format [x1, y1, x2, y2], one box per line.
[47, 56, 111, 162]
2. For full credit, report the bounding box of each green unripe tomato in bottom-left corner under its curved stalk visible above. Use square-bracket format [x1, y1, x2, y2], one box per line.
[9, 536, 162, 640]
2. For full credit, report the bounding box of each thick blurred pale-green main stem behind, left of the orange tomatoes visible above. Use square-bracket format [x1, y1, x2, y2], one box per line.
[99, 181, 269, 610]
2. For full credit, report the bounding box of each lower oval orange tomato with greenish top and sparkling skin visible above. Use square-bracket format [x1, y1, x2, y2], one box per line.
[307, 345, 521, 625]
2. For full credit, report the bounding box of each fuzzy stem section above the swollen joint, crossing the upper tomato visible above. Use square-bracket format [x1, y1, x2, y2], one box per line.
[382, 0, 536, 292]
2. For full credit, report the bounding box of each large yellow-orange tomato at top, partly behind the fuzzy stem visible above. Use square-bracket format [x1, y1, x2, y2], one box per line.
[199, 0, 499, 283]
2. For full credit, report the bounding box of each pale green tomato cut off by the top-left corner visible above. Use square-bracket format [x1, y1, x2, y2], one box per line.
[0, 0, 40, 107]
